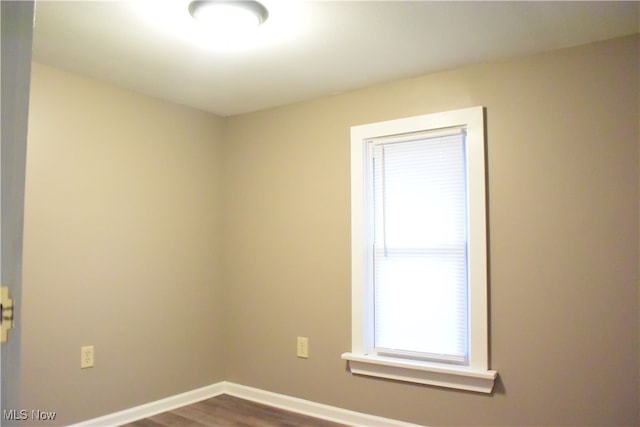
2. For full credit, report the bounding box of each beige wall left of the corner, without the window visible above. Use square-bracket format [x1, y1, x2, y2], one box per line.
[21, 64, 224, 425]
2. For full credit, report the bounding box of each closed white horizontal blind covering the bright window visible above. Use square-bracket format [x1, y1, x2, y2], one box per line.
[368, 128, 469, 364]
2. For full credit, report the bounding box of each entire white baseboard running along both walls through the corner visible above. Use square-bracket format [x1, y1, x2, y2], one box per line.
[70, 381, 417, 427]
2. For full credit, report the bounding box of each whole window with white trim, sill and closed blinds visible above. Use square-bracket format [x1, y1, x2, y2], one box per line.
[342, 107, 497, 393]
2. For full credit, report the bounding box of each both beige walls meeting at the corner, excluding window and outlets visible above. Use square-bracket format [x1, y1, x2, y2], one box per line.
[23, 37, 640, 425]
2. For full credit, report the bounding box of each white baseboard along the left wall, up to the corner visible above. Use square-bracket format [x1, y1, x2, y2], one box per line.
[70, 382, 225, 427]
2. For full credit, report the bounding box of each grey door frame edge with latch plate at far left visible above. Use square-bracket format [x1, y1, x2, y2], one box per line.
[0, 0, 35, 426]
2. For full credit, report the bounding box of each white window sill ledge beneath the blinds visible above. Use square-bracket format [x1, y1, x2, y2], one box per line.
[342, 353, 498, 393]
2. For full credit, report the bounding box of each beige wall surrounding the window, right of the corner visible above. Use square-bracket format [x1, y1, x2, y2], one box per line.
[223, 38, 640, 426]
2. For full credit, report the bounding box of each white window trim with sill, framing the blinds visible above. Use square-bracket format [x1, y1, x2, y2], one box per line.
[342, 107, 498, 393]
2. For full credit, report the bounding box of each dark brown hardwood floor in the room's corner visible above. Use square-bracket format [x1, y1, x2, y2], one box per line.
[122, 394, 346, 427]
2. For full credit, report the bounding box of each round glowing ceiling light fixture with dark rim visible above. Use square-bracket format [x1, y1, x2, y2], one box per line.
[189, 0, 269, 38]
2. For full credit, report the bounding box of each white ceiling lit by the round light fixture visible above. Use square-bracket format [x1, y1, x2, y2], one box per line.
[34, 0, 640, 116]
